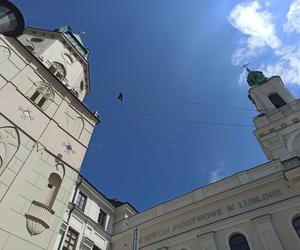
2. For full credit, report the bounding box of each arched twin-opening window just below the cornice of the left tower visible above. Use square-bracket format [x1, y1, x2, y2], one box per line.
[30, 84, 54, 110]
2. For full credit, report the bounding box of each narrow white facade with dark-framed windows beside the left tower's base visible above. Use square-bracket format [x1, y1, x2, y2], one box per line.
[54, 176, 137, 250]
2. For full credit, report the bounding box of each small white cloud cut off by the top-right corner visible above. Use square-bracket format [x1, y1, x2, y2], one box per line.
[284, 0, 300, 33]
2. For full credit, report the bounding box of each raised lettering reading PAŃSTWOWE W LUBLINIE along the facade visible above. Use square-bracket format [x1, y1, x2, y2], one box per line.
[140, 188, 282, 243]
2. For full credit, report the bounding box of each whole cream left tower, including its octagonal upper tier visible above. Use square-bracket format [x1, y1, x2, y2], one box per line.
[0, 26, 99, 250]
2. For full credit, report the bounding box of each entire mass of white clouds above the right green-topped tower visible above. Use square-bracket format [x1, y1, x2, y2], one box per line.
[228, 0, 300, 86]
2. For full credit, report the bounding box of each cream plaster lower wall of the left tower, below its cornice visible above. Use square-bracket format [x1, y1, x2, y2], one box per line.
[0, 35, 96, 250]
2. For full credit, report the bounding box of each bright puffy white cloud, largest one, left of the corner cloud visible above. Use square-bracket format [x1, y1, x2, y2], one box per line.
[228, 1, 281, 65]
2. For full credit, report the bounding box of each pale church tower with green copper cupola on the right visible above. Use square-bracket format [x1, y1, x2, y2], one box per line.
[247, 69, 300, 164]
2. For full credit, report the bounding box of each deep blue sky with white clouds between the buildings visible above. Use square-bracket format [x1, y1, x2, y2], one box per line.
[13, 0, 300, 211]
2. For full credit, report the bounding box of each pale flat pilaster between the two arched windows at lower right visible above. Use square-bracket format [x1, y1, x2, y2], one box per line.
[251, 214, 284, 250]
